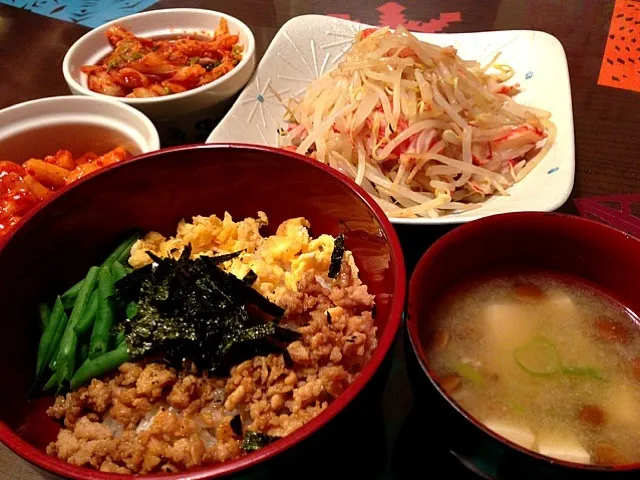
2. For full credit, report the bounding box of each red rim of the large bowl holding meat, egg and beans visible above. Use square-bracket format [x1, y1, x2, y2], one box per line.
[0, 143, 406, 480]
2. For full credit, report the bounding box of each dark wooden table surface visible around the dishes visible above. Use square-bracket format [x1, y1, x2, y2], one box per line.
[0, 0, 640, 480]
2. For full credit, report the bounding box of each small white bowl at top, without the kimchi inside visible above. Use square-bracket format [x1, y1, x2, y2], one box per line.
[62, 8, 256, 120]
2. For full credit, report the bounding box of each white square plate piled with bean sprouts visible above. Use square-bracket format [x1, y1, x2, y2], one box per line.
[208, 15, 575, 224]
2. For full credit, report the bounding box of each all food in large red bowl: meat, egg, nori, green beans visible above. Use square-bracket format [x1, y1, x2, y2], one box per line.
[37, 212, 377, 474]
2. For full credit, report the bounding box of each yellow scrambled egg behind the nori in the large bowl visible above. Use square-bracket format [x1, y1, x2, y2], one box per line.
[129, 212, 358, 302]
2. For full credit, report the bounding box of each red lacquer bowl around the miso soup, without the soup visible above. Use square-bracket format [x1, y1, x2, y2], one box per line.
[405, 212, 640, 479]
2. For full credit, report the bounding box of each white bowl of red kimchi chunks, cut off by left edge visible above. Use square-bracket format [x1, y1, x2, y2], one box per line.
[0, 95, 160, 236]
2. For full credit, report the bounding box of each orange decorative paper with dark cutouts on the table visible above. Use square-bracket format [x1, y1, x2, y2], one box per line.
[598, 0, 640, 92]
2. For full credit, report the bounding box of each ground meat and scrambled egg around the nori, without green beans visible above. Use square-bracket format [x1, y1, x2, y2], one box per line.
[42, 212, 377, 474]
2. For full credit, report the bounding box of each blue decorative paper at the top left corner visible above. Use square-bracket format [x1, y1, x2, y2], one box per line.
[0, 0, 158, 28]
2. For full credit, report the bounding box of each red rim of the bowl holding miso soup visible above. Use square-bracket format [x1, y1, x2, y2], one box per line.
[406, 212, 640, 472]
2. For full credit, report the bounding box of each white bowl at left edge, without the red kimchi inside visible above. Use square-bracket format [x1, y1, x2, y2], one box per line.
[0, 95, 160, 163]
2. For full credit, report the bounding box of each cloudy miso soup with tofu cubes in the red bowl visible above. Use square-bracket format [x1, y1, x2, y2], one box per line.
[421, 273, 640, 466]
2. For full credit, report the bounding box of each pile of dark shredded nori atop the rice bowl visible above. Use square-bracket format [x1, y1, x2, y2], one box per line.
[116, 245, 300, 374]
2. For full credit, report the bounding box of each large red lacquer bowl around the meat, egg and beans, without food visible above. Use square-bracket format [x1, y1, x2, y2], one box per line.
[0, 145, 406, 480]
